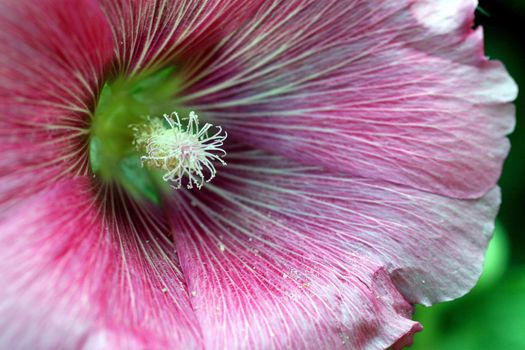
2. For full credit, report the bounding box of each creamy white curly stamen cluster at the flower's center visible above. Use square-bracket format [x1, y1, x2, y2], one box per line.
[132, 111, 228, 189]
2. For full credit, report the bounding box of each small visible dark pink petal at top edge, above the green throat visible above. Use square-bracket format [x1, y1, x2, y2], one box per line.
[96, 0, 262, 74]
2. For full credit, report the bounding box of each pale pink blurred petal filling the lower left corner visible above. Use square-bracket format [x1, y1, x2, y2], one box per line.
[0, 179, 201, 350]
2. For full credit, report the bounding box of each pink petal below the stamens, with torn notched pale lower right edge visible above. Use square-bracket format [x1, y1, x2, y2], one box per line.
[171, 146, 499, 349]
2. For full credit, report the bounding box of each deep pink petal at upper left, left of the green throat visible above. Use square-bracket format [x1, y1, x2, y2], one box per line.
[0, 0, 112, 215]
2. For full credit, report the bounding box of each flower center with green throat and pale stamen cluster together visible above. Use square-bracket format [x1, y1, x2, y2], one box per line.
[89, 67, 226, 204]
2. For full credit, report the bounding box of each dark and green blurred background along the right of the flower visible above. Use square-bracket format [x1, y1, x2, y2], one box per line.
[411, 0, 525, 350]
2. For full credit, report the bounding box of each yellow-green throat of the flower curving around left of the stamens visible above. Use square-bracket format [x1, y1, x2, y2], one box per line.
[90, 67, 184, 204]
